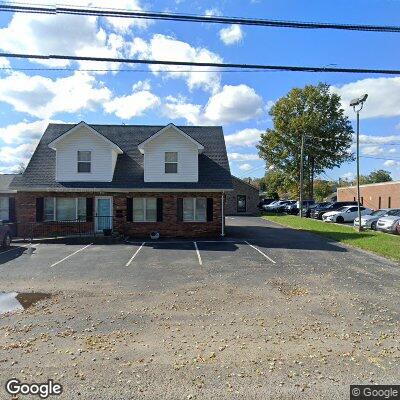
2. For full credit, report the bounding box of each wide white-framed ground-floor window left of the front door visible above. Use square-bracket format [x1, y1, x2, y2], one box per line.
[43, 197, 86, 221]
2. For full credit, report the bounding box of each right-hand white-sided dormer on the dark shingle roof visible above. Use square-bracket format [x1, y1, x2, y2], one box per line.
[139, 125, 202, 182]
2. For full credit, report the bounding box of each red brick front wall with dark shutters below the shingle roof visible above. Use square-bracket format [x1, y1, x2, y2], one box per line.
[16, 192, 225, 237]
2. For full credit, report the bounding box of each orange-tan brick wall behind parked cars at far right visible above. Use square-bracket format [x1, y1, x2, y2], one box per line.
[337, 182, 400, 210]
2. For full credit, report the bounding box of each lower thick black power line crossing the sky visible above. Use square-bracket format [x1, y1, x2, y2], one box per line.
[0, 53, 400, 75]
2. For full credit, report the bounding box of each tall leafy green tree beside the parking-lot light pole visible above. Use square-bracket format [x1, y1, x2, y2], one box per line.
[257, 83, 353, 198]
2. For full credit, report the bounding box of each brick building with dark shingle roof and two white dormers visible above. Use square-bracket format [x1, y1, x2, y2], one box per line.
[10, 122, 232, 237]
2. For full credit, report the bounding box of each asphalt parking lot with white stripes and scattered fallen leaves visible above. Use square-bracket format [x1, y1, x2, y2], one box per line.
[0, 217, 400, 399]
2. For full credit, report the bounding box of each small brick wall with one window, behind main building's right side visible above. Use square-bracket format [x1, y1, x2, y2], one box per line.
[226, 176, 260, 215]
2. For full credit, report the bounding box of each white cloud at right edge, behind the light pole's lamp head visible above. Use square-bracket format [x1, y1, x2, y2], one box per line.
[332, 77, 400, 118]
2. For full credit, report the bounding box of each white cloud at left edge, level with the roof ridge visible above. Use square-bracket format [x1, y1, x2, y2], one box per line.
[0, 120, 63, 144]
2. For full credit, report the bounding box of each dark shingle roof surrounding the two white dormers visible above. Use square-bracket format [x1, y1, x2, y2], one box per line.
[12, 124, 232, 190]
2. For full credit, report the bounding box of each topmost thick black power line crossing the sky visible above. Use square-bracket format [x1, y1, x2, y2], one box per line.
[0, 2, 400, 33]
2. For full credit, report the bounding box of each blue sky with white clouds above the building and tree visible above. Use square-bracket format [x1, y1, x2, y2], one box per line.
[0, 0, 400, 179]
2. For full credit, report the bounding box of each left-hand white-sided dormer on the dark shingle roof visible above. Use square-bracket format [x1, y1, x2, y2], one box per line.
[49, 123, 122, 182]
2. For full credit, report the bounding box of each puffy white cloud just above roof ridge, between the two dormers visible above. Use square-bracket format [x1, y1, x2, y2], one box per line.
[104, 81, 160, 119]
